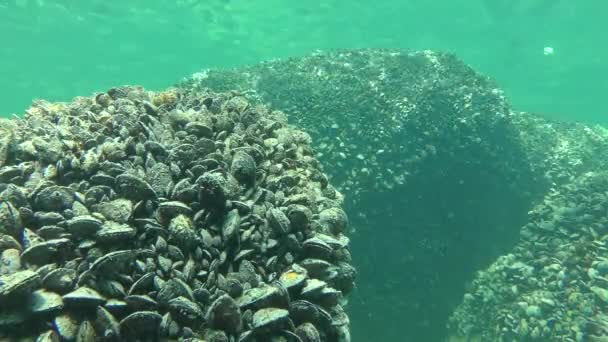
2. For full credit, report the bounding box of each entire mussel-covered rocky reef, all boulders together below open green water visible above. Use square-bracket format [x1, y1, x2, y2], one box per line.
[0, 49, 608, 342]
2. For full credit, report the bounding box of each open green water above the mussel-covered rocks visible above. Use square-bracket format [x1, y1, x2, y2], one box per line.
[0, 0, 608, 122]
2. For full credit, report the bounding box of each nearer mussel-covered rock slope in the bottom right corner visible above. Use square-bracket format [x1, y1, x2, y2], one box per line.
[448, 171, 608, 341]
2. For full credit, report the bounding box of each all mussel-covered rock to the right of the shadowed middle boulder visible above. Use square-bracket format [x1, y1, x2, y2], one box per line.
[449, 113, 608, 341]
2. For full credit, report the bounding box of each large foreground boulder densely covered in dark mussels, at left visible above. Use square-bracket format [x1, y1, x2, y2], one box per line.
[0, 87, 356, 341]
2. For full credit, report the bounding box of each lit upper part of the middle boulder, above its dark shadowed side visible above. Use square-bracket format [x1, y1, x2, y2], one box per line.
[181, 50, 526, 206]
